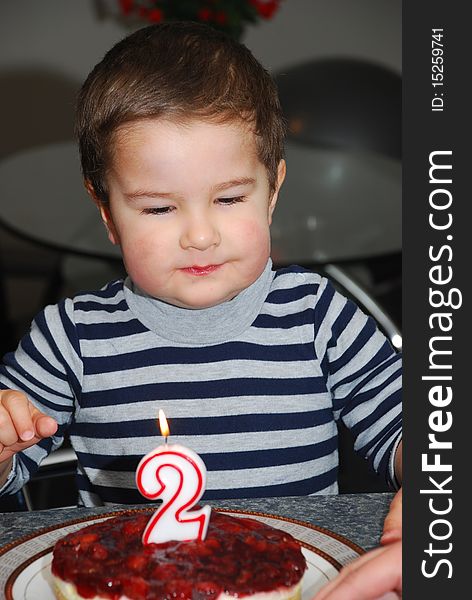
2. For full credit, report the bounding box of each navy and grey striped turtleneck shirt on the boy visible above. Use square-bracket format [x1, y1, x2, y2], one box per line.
[0, 261, 401, 506]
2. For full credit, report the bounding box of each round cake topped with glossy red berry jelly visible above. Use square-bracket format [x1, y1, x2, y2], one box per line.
[52, 511, 306, 600]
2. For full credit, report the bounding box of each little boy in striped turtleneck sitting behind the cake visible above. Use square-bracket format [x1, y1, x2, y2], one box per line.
[0, 23, 401, 506]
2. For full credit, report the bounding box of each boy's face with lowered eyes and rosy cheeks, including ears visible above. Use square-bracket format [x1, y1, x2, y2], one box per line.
[97, 120, 285, 308]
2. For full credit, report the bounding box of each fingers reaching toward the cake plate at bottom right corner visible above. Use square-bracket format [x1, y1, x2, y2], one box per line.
[314, 540, 402, 600]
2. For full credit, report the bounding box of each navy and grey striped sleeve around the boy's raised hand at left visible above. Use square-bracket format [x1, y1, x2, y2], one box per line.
[0, 300, 82, 493]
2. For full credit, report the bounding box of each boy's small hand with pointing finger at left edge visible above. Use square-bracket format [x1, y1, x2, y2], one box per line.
[0, 390, 57, 463]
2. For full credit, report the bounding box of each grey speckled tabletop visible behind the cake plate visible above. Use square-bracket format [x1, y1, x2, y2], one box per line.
[0, 493, 393, 550]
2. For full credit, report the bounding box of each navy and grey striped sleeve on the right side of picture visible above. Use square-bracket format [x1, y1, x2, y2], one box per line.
[315, 280, 402, 487]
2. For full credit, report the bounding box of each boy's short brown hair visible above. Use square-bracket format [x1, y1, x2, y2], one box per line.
[76, 22, 285, 203]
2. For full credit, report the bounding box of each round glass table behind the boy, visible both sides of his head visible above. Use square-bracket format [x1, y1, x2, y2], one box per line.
[0, 141, 401, 264]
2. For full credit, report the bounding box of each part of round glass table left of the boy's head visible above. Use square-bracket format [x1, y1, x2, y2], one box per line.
[0, 142, 120, 259]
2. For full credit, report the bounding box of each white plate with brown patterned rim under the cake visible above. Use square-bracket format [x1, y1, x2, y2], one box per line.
[0, 509, 364, 600]
